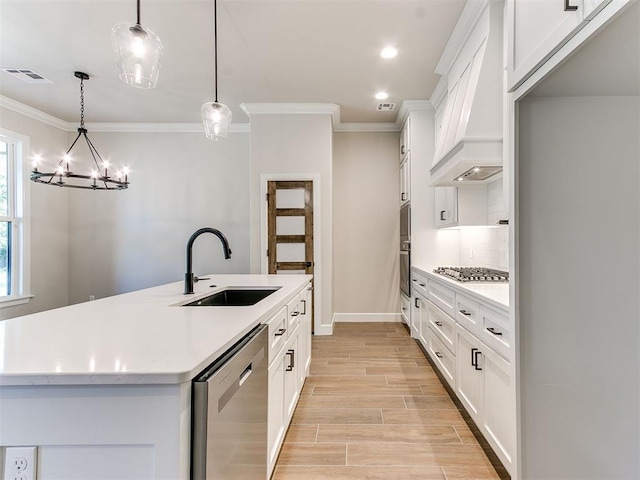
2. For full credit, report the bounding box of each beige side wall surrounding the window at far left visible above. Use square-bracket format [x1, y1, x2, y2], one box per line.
[0, 108, 69, 319]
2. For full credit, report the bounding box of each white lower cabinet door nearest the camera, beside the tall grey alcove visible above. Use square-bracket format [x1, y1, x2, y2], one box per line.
[482, 348, 516, 468]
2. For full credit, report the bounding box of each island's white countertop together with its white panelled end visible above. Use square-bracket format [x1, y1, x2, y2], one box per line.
[0, 275, 312, 480]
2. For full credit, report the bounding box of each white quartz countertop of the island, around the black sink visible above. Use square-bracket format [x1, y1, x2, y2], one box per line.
[0, 275, 312, 385]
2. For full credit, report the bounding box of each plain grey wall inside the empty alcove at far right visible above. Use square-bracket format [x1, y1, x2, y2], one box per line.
[517, 96, 640, 479]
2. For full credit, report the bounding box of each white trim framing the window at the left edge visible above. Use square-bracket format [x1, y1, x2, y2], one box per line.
[0, 128, 34, 308]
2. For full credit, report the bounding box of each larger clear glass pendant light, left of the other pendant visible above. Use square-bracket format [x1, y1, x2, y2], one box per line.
[111, 0, 162, 88]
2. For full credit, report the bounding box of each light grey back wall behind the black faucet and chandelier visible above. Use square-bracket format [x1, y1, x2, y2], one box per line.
[69, 131, 249, 303]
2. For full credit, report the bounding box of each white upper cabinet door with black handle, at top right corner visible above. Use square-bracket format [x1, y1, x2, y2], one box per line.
[507, 0, 584, 89]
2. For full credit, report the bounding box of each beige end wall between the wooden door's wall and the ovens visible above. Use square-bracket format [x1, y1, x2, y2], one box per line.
[333, 132, 400, 321]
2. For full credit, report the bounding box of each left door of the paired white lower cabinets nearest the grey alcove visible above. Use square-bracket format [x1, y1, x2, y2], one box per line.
[456, 325, 484, 425]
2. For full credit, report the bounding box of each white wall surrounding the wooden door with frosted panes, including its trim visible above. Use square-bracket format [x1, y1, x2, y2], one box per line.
[250, 114, 333, 334]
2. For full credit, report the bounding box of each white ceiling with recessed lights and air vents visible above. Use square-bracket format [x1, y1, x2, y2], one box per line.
[0, 0, 465, 123]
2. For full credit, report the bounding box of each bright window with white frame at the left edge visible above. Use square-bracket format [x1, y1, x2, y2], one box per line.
[0, 134, 28, 304]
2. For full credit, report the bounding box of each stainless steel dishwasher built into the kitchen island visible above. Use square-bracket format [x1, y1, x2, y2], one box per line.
[191, 325, 268, 480]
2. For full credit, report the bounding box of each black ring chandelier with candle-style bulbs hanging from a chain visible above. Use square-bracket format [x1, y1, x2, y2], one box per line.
[31, 72, 129, 190]
